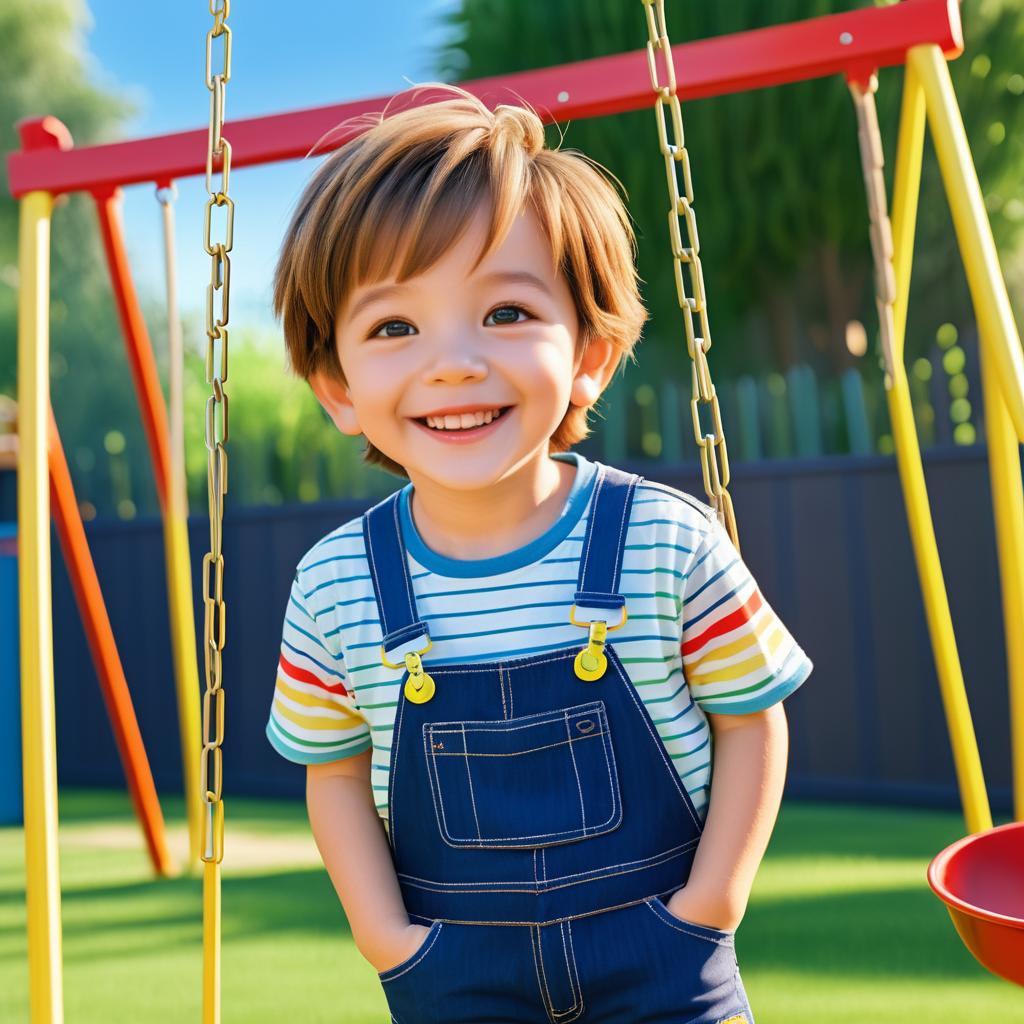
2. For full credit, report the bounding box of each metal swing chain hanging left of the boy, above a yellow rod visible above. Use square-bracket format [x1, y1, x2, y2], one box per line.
[201, 0, 234, 864]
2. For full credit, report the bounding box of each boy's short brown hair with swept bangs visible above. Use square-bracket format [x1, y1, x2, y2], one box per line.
[273, 83, 647, 476]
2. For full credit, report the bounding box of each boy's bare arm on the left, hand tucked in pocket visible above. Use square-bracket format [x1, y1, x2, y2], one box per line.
[306, 751, 427, 971]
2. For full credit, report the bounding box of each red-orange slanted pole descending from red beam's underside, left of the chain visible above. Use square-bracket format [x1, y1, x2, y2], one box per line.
[94, 190, 171, 515]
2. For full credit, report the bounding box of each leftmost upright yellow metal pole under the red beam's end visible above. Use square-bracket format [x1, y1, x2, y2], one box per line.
[17, 191, 63, 1024]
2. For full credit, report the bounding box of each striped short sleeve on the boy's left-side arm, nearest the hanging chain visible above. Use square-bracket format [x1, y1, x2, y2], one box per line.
[266, 578, 371, 764]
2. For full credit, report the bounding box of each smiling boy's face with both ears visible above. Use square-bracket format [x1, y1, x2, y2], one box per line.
[310, 208, 616, 490]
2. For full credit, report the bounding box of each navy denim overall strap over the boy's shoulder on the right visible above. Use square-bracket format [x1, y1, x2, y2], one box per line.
[574, 462, 643, 618]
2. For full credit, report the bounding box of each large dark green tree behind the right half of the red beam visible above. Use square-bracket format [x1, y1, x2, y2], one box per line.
[439, 0, 1024, 380]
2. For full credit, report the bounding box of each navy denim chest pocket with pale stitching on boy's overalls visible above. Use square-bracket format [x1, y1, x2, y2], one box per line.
[423, 700, 623, 849]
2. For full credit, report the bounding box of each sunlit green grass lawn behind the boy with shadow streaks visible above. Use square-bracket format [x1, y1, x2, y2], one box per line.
[0, 790, 1024, 1024]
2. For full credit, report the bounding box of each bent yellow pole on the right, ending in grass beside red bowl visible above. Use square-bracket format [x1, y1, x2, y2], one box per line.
[886, 65, 992, 833]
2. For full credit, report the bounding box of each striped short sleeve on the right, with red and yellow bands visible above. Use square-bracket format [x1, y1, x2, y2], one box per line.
[680, 520, 813, 715]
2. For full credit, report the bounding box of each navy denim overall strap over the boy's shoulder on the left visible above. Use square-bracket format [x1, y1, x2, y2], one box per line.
[362, 492, 430, 660]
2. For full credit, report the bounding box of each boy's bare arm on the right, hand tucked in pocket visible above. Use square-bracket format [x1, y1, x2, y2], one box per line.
[669, 701, 788, 930]
